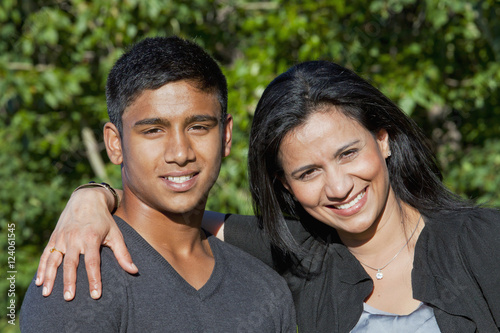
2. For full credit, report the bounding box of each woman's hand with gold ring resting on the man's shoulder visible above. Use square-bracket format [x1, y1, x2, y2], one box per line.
[36, 188, 138, 301]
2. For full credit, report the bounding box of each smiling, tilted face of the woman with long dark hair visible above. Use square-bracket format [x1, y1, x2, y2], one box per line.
[279, 106, 394, 236]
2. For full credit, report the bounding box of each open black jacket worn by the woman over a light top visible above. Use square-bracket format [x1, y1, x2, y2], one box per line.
[224, 208, 500, 333]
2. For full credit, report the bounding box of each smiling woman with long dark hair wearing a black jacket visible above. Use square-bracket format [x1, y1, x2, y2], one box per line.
[38, 61, 500, 332]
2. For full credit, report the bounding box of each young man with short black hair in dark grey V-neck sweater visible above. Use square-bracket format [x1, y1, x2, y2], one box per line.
[21, 37, 296, 332]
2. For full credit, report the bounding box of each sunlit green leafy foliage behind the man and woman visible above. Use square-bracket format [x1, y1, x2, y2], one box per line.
[0, 0, 500, 326]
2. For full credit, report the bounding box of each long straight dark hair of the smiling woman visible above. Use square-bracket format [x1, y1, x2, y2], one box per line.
[248, 61, 470, 254]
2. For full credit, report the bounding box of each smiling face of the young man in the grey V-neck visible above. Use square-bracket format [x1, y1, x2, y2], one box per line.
[108, 81, 232, 216]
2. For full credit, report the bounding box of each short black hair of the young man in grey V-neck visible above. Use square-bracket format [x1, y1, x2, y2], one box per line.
[106, 36, 227, 133]
